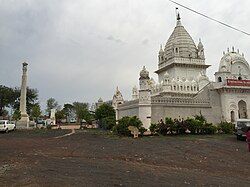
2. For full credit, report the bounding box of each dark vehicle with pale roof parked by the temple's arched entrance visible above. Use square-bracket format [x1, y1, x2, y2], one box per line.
[235, 119, 250, 140]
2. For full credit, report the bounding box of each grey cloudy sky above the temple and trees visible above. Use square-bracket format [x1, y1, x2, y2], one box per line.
[0, 0, 250, 109]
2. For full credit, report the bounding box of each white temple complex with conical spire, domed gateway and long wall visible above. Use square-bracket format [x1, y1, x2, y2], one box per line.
[112, 14, 250, 128]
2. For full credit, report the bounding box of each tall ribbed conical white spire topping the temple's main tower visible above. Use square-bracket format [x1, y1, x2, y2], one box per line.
[164, 17, 198, 59]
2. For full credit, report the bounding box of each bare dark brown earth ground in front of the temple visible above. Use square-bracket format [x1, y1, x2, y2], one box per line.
[0, 130, 250, 186]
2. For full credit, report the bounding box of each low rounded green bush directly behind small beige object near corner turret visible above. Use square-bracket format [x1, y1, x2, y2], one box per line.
[112, 116, 144, 136]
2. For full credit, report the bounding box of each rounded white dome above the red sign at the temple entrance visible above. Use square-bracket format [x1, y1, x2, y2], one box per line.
[219, 51, 249, 72]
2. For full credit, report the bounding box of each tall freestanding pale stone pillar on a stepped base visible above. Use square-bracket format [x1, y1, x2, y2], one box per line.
[17, 62, 29, 128]
